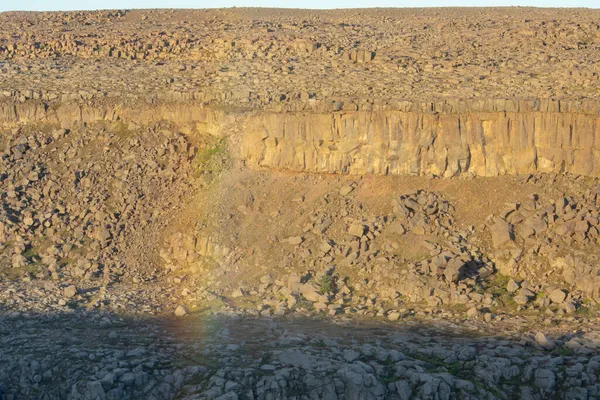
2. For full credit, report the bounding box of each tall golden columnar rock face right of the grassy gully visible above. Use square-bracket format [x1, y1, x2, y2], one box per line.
[241, 102, 600, 177]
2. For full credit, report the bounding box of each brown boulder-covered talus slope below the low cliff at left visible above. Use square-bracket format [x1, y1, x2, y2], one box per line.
[0, 122, 204, 282]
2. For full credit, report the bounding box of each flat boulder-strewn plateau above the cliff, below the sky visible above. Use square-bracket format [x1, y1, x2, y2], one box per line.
[0, 7, 600, 109]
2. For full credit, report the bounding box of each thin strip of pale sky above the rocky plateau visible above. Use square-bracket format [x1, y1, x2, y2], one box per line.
[0, 0, 600, 11]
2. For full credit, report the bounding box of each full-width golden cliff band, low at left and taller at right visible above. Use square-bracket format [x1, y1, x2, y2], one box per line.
[0, 100, 600, 177]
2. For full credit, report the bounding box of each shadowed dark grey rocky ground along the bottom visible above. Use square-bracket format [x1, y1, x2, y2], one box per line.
[0, 310, 600, 400]
